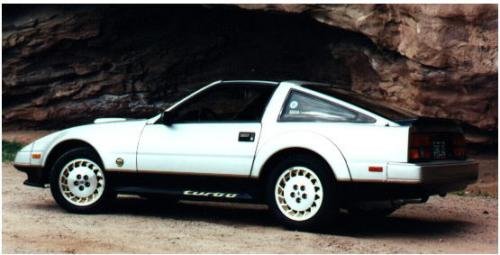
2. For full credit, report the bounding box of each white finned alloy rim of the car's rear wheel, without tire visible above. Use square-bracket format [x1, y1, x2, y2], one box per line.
[274, 166, 323, 221]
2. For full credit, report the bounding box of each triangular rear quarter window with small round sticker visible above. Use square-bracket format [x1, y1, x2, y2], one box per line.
[280, 91, 375, 123]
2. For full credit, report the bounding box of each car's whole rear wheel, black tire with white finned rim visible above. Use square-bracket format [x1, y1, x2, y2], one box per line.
[266, 155, 338, 229]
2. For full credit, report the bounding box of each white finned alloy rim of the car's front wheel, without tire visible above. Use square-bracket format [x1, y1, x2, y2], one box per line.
[59, 158, 105, 206]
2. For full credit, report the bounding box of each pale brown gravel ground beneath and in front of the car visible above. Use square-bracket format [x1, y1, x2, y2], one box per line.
[2, 163, 498, 253]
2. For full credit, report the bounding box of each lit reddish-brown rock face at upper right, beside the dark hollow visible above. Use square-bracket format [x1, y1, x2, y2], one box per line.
[240, 4, 498, 135]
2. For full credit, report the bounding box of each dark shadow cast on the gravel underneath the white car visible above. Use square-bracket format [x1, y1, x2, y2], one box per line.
[37, 197, 474, 237]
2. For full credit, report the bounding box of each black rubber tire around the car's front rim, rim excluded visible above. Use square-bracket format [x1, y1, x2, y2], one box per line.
[50, 147, 116, 213]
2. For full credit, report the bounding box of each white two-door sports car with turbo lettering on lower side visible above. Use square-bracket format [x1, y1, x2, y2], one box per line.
[14, 81, 478, 228]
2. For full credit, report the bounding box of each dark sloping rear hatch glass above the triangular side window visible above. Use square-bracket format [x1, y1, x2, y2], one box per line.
[303, 85, 418, 121]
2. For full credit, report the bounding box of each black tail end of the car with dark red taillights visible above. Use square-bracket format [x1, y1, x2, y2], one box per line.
[397, 117, 467, 162]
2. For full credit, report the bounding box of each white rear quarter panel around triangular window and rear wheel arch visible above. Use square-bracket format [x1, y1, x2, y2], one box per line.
[251, 83, 409, 181]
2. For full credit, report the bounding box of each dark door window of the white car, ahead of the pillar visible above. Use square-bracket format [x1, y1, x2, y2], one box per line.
[175, 84, 275, 123]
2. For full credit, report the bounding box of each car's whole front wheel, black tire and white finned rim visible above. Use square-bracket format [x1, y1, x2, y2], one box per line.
[50, 148, 113, 213]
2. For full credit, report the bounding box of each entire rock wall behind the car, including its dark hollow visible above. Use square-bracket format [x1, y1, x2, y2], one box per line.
[2, 5, 498, 142]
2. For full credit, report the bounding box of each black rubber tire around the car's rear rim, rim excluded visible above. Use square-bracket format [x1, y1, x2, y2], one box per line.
[266, 155, 339, 230]
